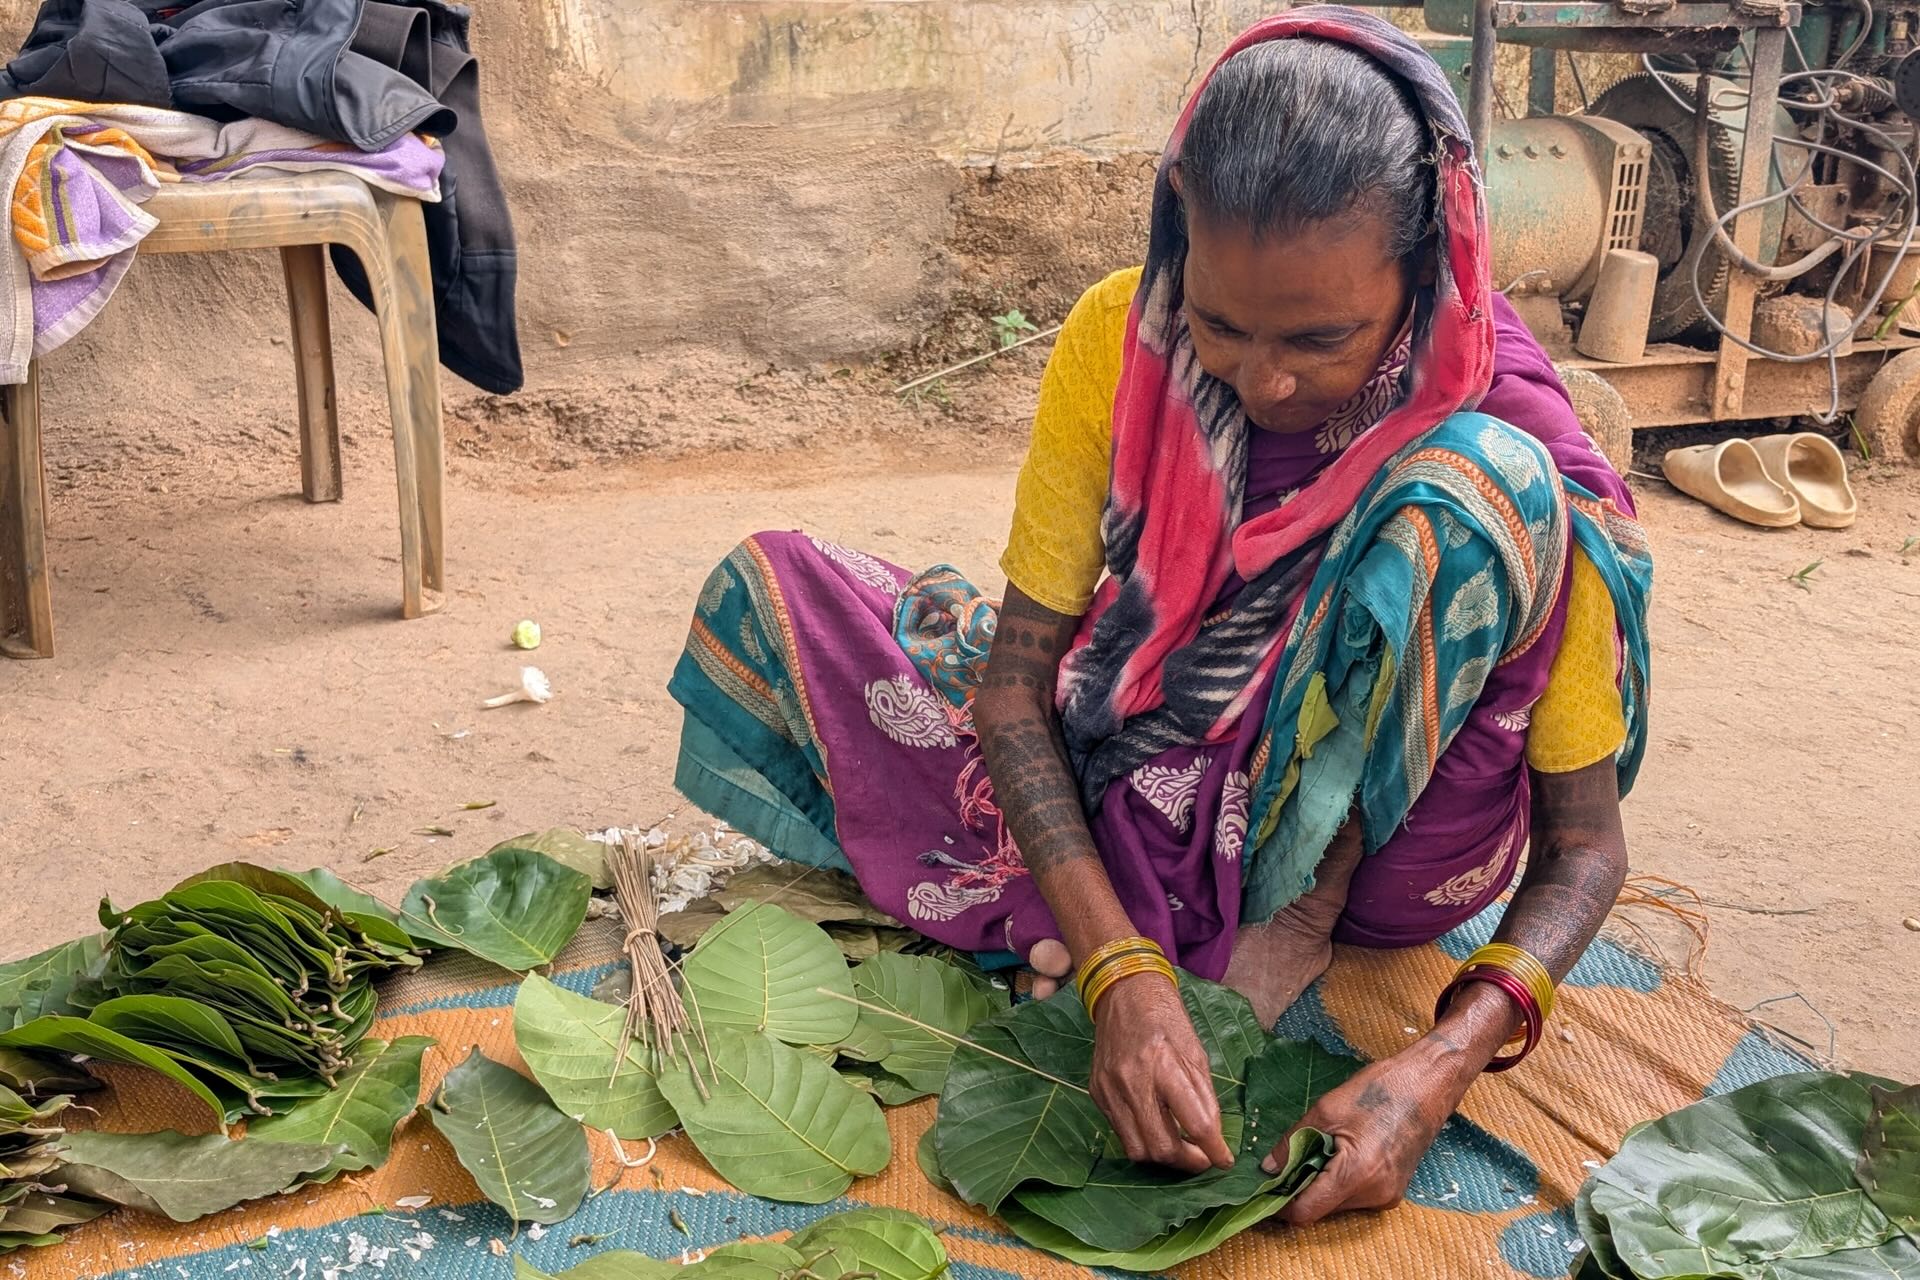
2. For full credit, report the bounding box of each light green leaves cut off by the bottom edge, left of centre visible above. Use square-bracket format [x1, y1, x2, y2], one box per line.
[513, 1209, 948, 1280]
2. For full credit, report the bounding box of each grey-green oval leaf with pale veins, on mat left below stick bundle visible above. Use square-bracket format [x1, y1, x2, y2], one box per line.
[430, 1048, 591, 1226]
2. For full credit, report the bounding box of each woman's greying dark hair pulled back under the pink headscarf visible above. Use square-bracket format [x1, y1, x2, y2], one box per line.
[1179, 38, 1438, 261]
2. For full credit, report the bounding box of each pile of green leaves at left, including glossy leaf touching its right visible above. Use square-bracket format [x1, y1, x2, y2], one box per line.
[0, 846, 591, 1121]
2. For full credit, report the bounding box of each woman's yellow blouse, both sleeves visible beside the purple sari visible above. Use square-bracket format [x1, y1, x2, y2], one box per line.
[1000, 267, 1626, 773]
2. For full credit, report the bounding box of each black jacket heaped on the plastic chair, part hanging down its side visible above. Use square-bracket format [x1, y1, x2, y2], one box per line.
[0, 0, 522, 393]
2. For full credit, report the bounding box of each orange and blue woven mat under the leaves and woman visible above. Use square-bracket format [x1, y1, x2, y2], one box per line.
[18, 908, 1809, 1280]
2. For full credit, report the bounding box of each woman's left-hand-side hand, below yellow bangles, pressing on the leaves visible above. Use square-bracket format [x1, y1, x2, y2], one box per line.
[1091, 973, 1233, 1173]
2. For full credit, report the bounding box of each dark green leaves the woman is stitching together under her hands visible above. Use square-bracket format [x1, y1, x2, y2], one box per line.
[920, 975, 1361, 1270]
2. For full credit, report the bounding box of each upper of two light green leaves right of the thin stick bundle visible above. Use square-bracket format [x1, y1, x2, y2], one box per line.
[680, 902, 860, 1044]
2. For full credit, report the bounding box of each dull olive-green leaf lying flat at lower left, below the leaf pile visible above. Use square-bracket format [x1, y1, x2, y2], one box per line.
[54, 1132, 342, 1222]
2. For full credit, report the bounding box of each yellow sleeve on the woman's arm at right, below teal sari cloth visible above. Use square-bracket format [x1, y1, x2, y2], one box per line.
[1526, 547, 1626, 773]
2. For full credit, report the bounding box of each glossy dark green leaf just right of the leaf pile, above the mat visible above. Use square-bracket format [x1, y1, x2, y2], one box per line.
[399, 848, 593, 973]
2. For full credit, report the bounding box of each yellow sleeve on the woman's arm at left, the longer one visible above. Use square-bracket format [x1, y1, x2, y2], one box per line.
[1000, 267, 1140, 618]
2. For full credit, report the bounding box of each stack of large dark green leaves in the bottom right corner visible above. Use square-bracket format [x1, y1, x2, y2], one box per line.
[1574, 1071, 1920, 1280]
